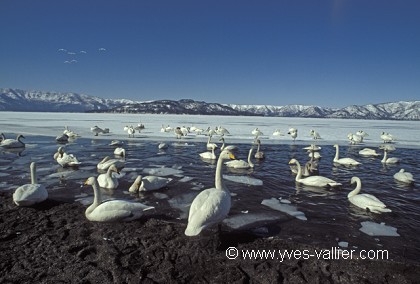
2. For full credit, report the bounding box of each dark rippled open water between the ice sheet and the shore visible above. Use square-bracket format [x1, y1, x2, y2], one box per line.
[0, 136, 420, 261]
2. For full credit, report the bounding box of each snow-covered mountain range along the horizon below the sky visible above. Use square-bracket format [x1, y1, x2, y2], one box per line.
[0, 89, 420, 120]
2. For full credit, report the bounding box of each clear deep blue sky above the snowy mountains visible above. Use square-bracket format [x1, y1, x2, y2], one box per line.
[0, 0, 420, 107]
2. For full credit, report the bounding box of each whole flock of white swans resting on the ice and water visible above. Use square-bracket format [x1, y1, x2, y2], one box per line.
[0, 124, 414, 236]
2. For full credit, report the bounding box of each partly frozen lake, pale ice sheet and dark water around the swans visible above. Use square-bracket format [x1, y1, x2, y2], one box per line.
[0, 112, 420, 261]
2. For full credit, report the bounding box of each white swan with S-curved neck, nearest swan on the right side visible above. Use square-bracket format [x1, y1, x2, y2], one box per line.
[347, 177, 392, 213]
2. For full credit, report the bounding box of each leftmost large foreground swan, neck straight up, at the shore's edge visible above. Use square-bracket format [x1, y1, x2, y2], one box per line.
[13, 162, 48, 206]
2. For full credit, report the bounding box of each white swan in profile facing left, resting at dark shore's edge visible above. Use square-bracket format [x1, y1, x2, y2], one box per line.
[85, 177, 154, 222]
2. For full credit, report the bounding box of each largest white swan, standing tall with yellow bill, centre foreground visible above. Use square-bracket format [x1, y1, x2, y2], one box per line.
[185, 149, 235, 236]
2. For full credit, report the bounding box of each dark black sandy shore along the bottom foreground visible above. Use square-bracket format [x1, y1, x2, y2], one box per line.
[0, 192, 420, 283]
